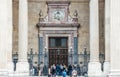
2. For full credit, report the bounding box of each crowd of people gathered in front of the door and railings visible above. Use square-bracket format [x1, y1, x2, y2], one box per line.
[31, 64, 87, 77]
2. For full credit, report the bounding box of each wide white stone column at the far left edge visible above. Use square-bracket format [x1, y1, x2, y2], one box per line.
[0, 0, 13, 76]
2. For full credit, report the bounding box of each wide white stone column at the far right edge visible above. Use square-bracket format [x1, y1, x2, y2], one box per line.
[109, 0, 120, 77]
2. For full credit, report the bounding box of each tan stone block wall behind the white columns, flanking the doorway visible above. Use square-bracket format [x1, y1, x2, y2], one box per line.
[13, 0, 104, 65]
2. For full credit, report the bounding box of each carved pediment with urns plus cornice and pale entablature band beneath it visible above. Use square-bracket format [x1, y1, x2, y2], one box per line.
[37, 1, 80, 37]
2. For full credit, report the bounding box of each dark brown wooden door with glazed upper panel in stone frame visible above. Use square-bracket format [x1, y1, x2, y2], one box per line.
[49, 37, 68, 66]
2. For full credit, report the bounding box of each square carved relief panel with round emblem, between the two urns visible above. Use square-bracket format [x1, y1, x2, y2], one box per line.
[47, 1, 70, 22]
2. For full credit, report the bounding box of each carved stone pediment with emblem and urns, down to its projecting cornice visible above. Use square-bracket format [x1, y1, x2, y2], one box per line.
[37, 1, 79, 27]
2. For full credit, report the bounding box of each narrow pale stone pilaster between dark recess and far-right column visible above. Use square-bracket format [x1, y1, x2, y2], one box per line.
[104, 0, 110, 76]
